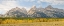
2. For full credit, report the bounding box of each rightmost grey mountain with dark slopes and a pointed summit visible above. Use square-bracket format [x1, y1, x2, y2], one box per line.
[43, 6, 64, 17]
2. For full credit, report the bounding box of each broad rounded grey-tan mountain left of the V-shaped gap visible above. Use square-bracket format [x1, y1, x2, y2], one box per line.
[5, 7, 27, 17]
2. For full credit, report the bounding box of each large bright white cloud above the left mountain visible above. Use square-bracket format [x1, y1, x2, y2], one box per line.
[0, 1, 22, 13]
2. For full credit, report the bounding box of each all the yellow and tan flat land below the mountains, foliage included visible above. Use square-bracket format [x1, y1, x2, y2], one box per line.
[0, 17, 64, 26]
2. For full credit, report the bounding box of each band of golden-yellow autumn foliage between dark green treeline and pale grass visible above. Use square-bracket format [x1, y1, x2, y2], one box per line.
[0, 18, 64, 24]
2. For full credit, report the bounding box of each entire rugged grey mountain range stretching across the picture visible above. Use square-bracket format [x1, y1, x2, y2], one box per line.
[0, 5, 64, 18]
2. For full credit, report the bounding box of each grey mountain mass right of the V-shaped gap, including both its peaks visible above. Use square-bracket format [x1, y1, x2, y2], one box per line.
[28, 5, 64, 17]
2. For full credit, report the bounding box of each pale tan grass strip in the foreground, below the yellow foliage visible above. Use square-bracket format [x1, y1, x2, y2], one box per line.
[0, 21, 64, 26]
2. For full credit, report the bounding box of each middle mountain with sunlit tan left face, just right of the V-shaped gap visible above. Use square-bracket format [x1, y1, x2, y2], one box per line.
[28, 6, 47, 17]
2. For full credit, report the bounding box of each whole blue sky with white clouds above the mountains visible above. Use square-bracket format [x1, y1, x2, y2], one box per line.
[0, 0, 64, 14]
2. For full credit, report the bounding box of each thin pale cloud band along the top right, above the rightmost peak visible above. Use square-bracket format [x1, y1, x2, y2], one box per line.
[38, 0, 64, 5]
